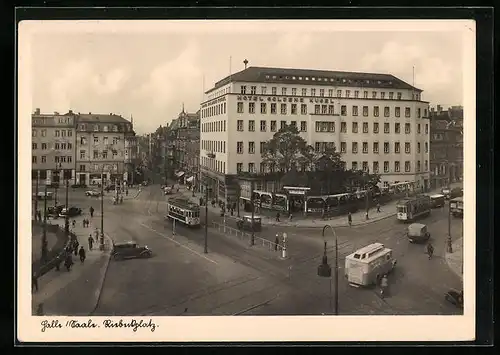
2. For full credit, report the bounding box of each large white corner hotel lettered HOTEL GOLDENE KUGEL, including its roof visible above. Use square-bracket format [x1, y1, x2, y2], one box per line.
[200, 67, 429, 204]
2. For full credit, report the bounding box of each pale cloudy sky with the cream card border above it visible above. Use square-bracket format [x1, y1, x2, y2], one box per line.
[19, 20, 470, 134]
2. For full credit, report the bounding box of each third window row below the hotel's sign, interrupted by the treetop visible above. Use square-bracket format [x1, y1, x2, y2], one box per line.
[234, 141, 429, 154]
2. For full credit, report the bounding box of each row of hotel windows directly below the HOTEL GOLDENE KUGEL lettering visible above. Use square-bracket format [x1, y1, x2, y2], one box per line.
[235, 102, 427, 118]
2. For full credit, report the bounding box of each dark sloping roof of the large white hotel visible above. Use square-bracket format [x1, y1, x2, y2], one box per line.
[206, 67, 422, 93]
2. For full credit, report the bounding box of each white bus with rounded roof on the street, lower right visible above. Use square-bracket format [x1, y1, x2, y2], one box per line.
[345, 243, 396, 287]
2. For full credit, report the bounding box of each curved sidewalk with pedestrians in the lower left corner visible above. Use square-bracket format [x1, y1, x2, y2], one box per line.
[32, 216, 112, 315]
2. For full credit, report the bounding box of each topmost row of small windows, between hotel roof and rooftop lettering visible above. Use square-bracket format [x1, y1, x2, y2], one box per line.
[240, 85, 414, 100]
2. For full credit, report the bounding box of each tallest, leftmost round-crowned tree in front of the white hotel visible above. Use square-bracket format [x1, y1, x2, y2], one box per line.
[262, 125, 309, 173]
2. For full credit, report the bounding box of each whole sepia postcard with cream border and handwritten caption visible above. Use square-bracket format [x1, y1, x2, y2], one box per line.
[17, 20, 476, 342]
